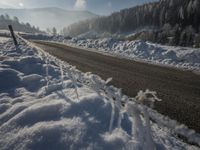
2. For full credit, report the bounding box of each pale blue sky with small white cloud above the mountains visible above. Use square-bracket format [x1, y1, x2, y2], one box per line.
[0, 0, 155, 15]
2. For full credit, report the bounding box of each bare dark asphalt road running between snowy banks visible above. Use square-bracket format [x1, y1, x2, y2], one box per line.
[34, 41, 200, 133]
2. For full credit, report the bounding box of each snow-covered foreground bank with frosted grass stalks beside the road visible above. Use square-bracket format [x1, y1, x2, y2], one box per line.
[0, 38, 200, 150]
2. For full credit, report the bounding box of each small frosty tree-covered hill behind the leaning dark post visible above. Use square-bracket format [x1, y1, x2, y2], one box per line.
[0, 14, 42, 33]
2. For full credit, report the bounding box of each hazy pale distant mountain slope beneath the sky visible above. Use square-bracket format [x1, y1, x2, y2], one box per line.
[0, 7, 97, 29]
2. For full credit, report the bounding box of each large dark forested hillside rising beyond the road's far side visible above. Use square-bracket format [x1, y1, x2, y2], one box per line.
[65, 0, 200, 47]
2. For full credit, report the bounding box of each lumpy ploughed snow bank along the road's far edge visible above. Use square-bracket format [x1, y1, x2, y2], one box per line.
[54, 38, 200, 71]
